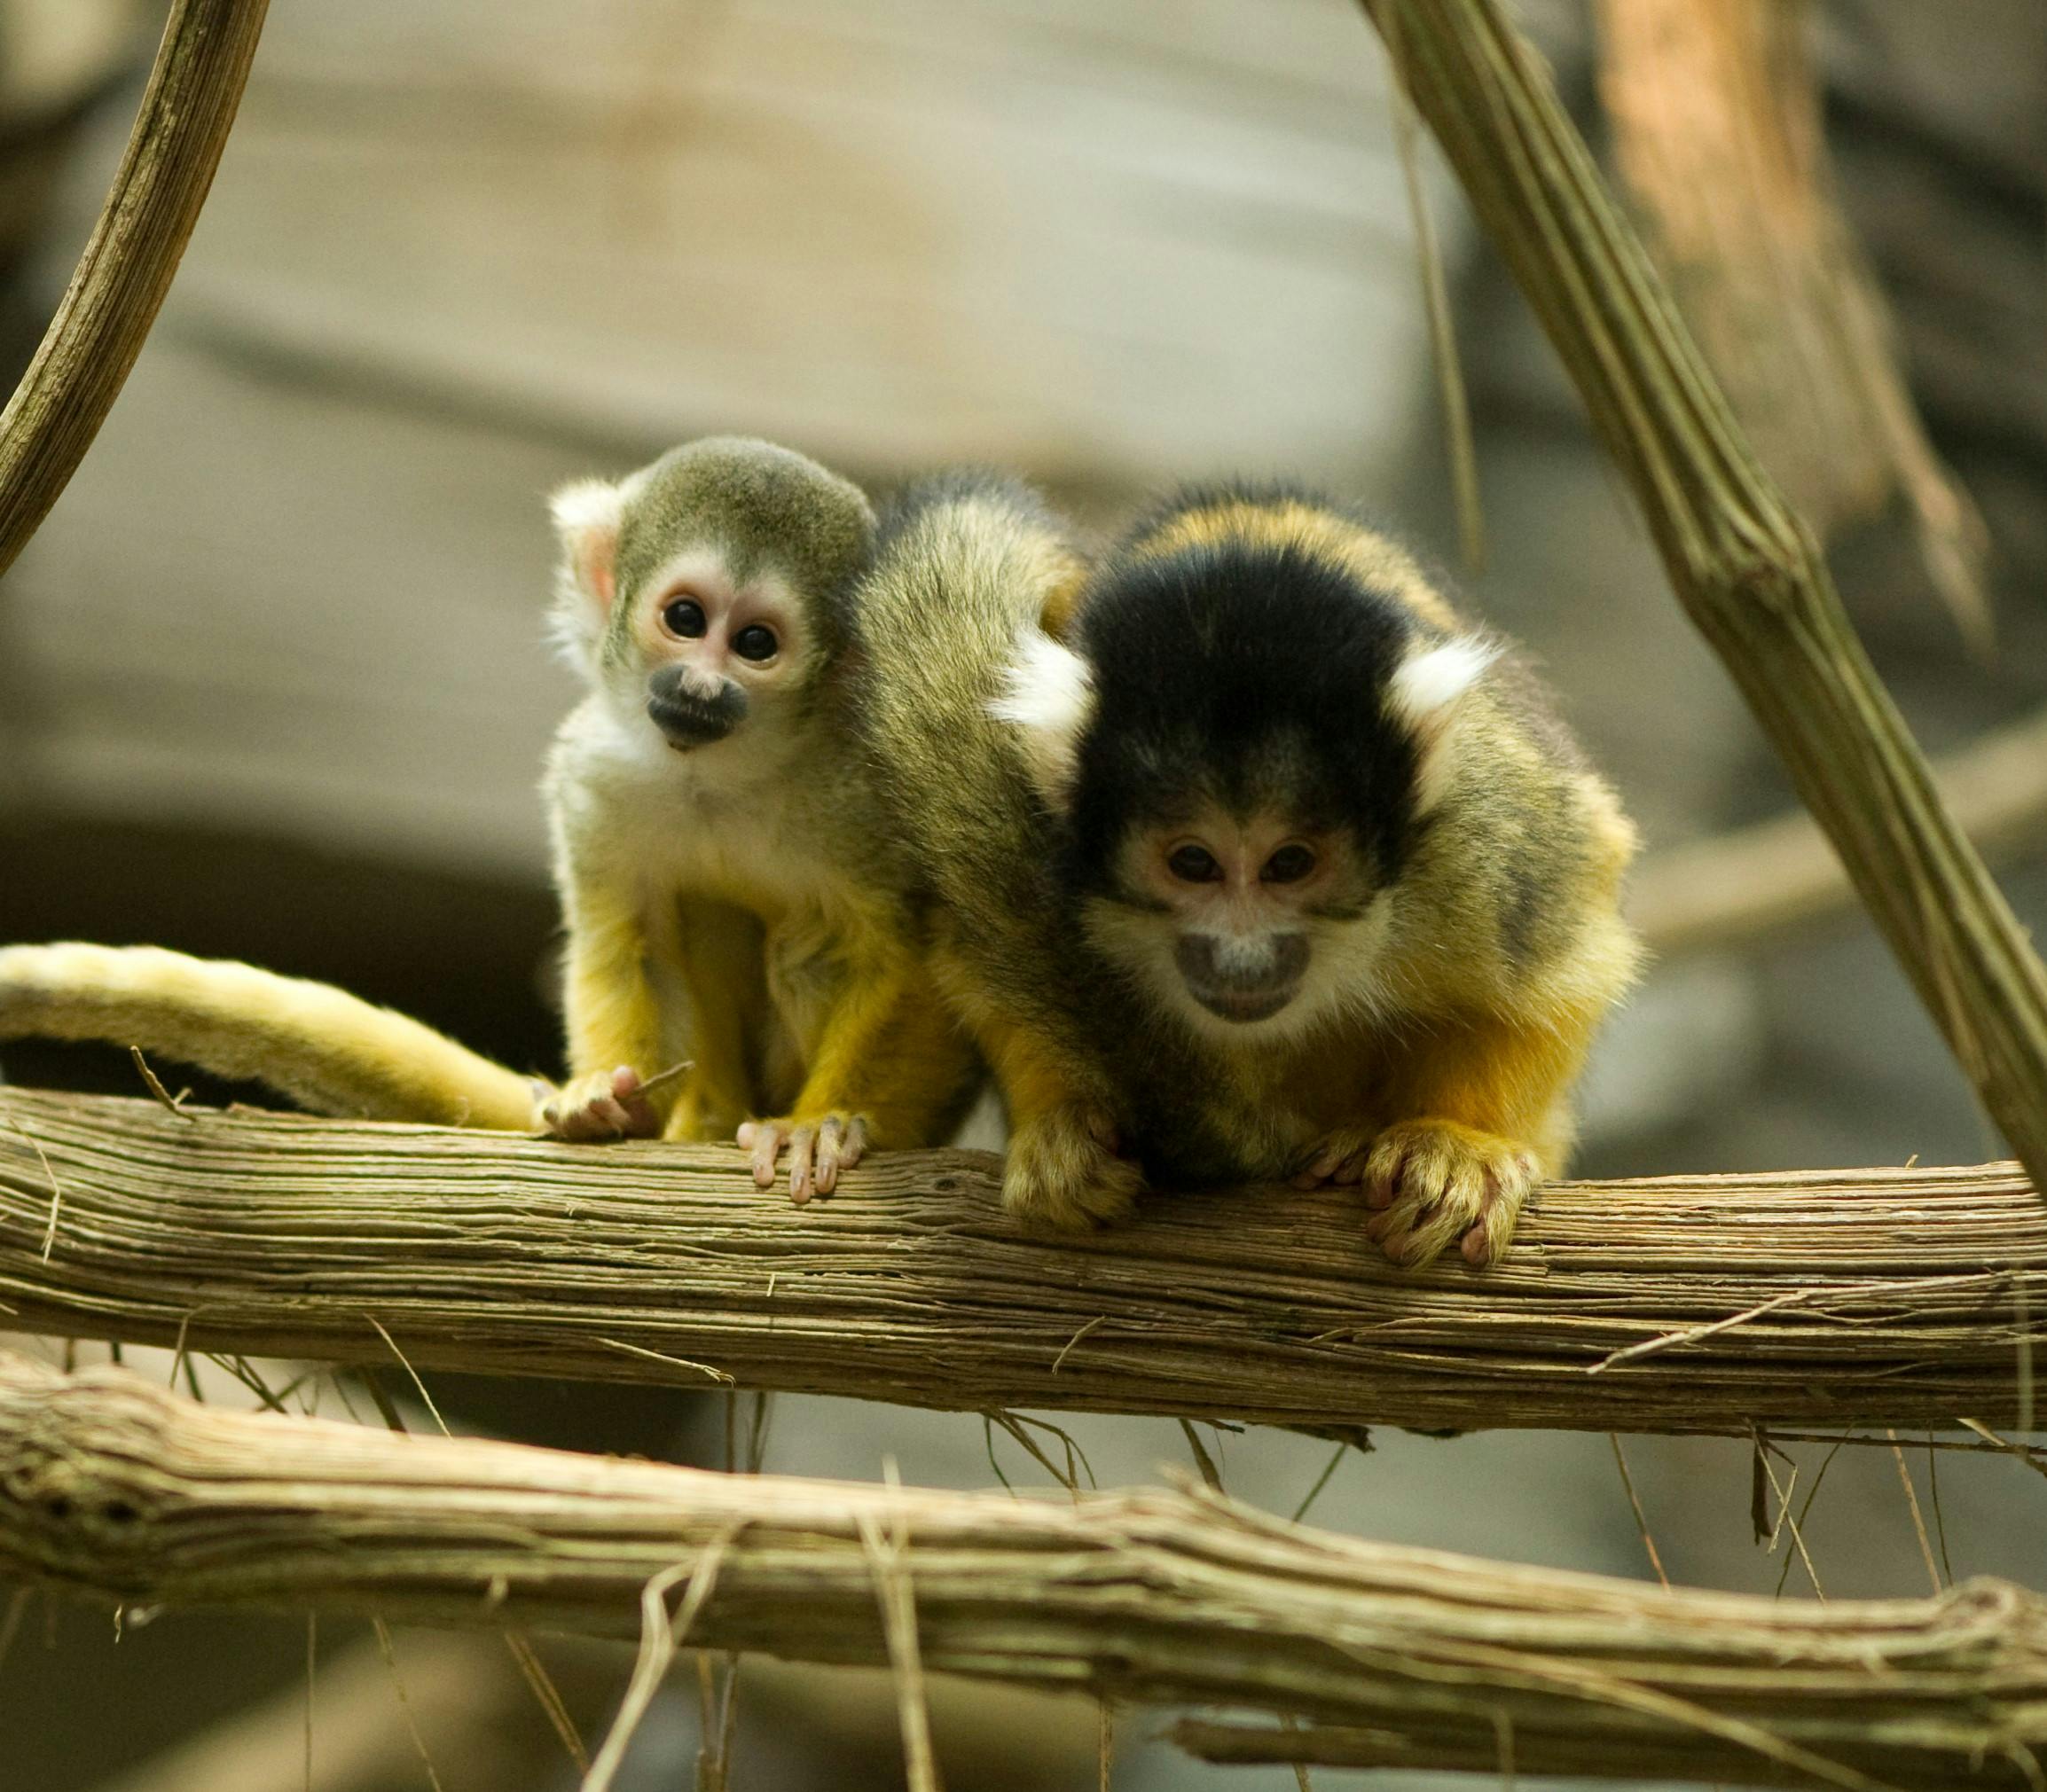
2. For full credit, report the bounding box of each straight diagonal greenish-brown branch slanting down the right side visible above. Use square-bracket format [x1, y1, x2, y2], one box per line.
[1363, 0, 2047, 1186]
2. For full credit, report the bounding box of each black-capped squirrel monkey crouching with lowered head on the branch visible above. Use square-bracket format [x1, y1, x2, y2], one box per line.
[856, 468, 1640, 1266]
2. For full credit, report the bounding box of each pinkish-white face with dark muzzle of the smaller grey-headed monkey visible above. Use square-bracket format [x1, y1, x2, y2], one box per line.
[620, 551, 809, 753]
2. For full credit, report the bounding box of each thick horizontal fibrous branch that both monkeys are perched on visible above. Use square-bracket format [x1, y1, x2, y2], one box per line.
[0, 1091, 2047, 1432]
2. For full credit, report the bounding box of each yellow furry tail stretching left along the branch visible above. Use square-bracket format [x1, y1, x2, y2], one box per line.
[0, 945, 534, 1131]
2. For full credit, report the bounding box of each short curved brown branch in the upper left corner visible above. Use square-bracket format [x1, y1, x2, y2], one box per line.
[0, 0, 268, 575]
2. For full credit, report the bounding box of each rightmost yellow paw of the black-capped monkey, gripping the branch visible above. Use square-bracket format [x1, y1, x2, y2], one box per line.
[1359, 1119, 1541, 1268]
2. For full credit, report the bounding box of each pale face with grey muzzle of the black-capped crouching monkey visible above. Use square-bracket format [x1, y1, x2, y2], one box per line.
[1089, 804, 1376, 1044]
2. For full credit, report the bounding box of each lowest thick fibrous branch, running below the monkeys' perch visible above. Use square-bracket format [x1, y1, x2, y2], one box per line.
[0, 1357, 2047, 1788]
